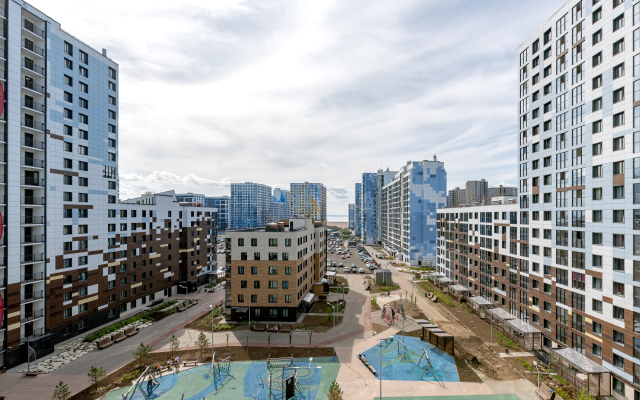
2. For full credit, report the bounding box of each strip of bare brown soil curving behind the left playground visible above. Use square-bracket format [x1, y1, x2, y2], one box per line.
[69, 346, 333, 400]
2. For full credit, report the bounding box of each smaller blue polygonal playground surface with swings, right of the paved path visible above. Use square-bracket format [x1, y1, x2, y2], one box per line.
[362, 336, 460, 382]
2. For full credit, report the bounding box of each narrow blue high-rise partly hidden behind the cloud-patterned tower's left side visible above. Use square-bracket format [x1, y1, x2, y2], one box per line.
[360, 168, 397, 245]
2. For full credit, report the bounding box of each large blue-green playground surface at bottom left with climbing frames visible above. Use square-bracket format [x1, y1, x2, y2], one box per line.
[104, 357, 340, 400]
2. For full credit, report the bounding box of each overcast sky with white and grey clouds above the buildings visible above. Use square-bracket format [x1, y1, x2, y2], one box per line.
[30, 0, 564, 219]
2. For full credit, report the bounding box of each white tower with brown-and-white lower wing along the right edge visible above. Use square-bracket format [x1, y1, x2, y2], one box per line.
[438, 0, 640, 399]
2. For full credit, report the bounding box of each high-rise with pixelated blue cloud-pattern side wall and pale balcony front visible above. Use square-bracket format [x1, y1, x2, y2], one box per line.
[379, 157, 447, 265]
